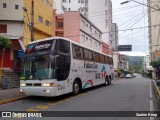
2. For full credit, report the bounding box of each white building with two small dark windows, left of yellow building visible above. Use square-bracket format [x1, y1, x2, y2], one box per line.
[0, 0, 24, 36]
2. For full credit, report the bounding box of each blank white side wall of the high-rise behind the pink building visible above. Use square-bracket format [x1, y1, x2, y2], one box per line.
[88, 0, 112, 46]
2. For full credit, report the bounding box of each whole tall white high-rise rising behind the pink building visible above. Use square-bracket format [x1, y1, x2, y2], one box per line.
[55, 0, 112, 45]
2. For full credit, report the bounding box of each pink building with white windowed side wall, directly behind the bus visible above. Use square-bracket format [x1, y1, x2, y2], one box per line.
[55, 11, 102, 51]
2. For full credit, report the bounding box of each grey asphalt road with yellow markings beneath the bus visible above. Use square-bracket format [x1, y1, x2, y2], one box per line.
[0, 77, 158, 120]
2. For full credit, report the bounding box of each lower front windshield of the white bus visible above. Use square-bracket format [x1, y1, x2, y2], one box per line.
[23, 55, 53, 80]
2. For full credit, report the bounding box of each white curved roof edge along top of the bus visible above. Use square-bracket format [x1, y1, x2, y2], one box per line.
[29, 37, 112, 57]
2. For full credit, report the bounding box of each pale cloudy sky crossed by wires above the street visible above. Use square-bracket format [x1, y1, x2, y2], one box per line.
[112, 0, 149, 56]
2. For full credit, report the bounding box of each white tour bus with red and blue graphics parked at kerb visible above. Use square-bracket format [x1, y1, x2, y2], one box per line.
[20, 37, 114, 97]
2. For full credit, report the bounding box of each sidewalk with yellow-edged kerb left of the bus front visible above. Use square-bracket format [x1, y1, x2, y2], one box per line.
[0, 88, 26, 105]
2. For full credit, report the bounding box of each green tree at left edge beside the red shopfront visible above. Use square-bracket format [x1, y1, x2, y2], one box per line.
[0, 36, 12, 80]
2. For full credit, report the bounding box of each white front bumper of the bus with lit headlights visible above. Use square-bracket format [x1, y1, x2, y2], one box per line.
[20, 87, 57, 97]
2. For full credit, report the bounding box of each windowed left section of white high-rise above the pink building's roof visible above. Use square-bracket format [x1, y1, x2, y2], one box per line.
[55, 0, 89, 17]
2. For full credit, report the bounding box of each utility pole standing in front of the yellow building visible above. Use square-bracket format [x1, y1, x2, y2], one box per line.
[31, 0, 34, 41]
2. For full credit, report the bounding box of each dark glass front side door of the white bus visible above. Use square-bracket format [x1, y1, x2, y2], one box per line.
[52, 39, 71, 88]
